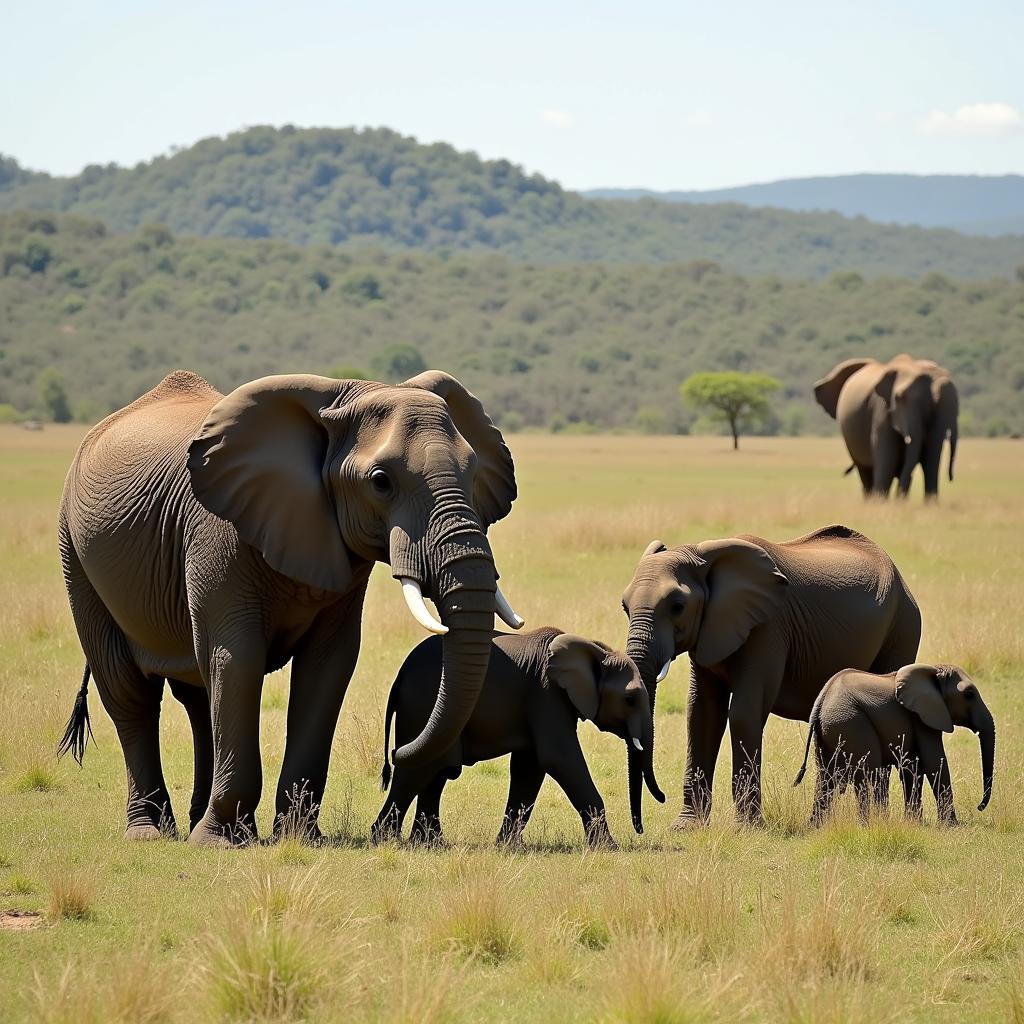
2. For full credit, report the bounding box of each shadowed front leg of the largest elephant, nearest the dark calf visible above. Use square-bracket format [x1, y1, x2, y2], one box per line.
[274, 592, 362, 843]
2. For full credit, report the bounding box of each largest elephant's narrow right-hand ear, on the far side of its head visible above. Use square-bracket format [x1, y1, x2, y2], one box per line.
[400, 370, 517, 529]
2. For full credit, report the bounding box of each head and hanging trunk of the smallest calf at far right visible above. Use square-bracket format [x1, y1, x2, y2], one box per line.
[896, 665, 995, 811]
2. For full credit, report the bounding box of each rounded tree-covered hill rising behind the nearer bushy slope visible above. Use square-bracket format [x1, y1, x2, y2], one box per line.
[0, 127, 1024, 279]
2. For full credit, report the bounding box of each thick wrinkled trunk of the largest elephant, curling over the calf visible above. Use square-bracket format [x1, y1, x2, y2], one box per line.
[391, 503, 498, 767]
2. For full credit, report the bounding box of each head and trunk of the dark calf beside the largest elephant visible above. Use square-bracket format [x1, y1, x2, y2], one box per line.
[545, 633, 665, 833]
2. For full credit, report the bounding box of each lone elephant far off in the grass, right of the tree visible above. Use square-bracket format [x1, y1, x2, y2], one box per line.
[814, 354, 959, 499]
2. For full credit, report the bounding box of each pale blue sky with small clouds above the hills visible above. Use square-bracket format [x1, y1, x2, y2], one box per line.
[0, 0, 1024, 188]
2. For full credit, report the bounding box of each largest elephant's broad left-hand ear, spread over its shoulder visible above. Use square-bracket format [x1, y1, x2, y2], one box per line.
[188, 374, 364, 592]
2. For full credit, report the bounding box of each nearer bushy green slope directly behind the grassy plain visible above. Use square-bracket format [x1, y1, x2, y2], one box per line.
[0, 211, 1024, 434]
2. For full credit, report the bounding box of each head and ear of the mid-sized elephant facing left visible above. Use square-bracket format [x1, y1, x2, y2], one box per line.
[623, 538, 788, 707]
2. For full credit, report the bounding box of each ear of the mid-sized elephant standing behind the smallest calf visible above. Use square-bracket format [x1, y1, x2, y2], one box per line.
[693, 538, 790, 666]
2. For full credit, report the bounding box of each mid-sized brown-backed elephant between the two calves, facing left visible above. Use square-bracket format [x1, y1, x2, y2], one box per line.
[623, 526, 921, 828]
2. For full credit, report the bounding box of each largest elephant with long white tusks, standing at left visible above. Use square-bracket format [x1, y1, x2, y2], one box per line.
[59, 371, 522, 845]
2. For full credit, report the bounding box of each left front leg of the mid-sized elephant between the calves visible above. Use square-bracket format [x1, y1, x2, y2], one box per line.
[672, 668, 729, 830]
